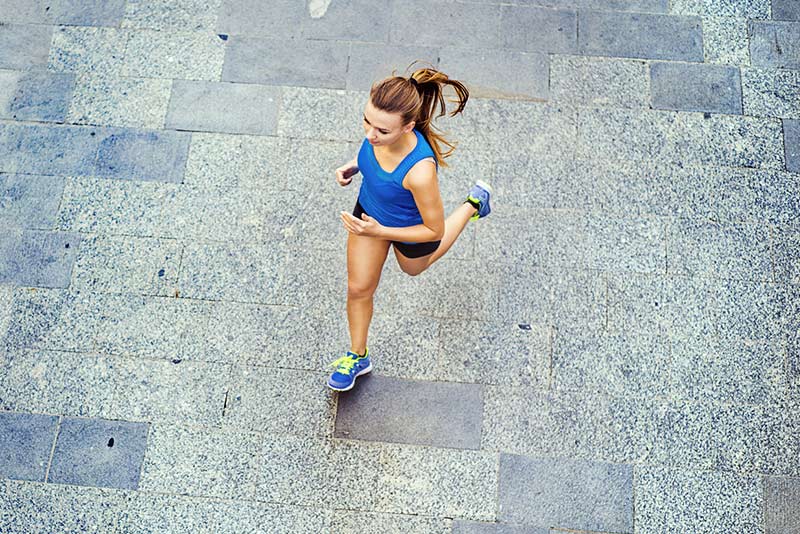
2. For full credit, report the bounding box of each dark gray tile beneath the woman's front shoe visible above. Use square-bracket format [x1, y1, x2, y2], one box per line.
[334, 375, 483, 449]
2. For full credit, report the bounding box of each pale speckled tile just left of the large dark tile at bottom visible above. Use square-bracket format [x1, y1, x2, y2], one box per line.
[375, 445, 497, 521]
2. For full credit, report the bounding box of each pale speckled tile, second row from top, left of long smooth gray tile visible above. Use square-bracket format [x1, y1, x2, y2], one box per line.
[120, 30, 226, 81]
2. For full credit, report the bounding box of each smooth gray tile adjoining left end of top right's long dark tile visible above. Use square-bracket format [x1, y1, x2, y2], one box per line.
[500, 6, 578, 53]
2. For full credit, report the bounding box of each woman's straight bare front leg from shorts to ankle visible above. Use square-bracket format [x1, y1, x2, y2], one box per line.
[347, 234, 390, 354]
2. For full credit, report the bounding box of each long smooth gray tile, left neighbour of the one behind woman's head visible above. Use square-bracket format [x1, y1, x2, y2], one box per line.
[222, 36, 349, 89]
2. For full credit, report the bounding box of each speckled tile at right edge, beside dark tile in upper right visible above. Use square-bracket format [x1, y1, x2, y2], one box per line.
[742, 69, 800, 119]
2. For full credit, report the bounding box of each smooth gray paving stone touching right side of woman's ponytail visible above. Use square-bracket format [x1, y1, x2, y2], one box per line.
[439, 47, 549, 100]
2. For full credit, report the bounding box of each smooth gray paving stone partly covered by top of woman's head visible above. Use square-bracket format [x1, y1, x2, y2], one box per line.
[345, 42, 438, 91]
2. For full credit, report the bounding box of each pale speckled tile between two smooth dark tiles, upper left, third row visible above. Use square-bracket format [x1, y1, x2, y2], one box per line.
[68, 73, 172, 129]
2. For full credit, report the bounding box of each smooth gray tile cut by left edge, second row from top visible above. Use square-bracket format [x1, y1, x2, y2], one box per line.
[0, 23, 53, 70]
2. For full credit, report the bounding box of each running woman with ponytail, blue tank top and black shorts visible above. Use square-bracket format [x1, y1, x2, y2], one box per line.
[328, 68, 492, 391]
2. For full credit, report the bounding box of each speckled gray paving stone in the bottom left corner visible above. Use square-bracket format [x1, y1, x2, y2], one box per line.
[0, 480, 124, 534]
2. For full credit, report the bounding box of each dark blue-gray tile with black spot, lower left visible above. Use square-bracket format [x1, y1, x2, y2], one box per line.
[48, 418, 149, 489]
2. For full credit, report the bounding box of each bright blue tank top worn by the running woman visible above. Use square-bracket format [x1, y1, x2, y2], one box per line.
[358, 130, 439, 232]
